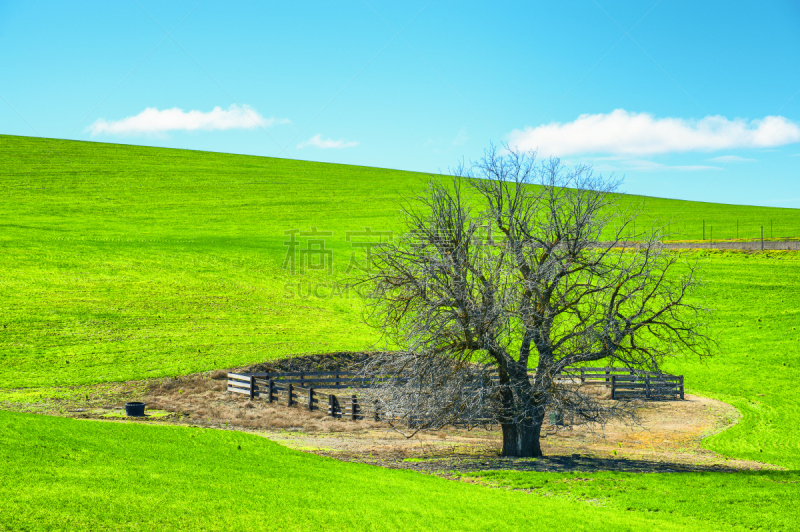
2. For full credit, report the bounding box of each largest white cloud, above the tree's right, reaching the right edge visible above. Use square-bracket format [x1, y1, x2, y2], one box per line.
[509, 109, 800, 157]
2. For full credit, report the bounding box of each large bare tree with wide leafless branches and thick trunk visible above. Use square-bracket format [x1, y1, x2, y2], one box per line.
[360, 147, 709, 457]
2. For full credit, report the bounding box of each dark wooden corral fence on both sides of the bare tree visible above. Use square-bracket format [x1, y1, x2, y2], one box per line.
[228, 367, 684, 423]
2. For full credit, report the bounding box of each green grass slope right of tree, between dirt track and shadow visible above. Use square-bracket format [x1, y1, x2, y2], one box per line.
[668, 251, 800, 469]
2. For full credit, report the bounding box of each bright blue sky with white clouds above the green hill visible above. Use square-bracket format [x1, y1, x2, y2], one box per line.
[0, 0, 800, 208]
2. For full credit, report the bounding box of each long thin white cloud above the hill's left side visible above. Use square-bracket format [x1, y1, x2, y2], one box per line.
[86, 104, 282, 135]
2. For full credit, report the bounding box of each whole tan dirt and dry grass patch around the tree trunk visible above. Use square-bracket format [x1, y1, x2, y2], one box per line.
[0, 371, 776, 476]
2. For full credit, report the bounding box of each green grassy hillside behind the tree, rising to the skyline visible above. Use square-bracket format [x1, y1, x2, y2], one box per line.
[0, 136, 800, 387]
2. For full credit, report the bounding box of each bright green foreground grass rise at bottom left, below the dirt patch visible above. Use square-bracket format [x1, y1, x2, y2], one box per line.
[0, 411, 721, 532]
